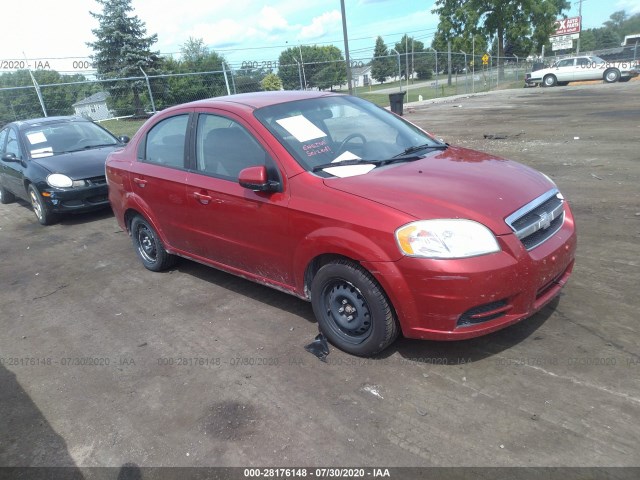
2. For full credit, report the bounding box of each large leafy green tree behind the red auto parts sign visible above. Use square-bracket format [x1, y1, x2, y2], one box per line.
[433, 0, 569, 75]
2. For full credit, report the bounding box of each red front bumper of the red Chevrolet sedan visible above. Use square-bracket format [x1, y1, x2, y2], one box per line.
[363, 207, 577, 340]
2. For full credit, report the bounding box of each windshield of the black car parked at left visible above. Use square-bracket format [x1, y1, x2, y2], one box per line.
[25, 122, 118, 158]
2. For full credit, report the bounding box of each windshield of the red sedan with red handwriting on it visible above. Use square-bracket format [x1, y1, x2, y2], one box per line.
[255, 95, 446, 176]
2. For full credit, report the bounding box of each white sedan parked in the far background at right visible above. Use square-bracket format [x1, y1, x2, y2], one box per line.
[524, 55, 638, 87]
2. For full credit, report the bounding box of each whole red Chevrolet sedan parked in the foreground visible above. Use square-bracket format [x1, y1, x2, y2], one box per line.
[106, 92, 576, 355]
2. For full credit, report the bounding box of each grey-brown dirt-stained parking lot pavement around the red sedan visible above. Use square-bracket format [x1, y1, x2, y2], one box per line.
[0, 82, 640, 467]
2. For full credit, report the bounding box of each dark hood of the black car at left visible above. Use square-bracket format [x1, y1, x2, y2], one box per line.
[31, 145, 122, 180]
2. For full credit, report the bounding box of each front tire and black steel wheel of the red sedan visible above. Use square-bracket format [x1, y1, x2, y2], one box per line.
[311, 260, 398, 356]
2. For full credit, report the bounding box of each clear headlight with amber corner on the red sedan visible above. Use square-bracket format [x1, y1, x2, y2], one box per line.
[396, 219, 500, 258]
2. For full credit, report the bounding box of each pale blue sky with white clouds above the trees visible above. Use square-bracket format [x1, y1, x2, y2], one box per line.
[0, 0, 640, 73]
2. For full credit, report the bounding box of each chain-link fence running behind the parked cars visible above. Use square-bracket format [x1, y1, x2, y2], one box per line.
[0, 51, 552, 125]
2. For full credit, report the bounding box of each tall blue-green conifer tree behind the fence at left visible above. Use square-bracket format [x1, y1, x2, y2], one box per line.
[87, 0, 160, 115]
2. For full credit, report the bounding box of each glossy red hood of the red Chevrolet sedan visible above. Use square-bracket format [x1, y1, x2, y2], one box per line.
[324, 147, 554, 235]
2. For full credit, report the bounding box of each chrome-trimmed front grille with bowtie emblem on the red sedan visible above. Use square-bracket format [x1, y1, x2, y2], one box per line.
[505, 188, 564, 250]
